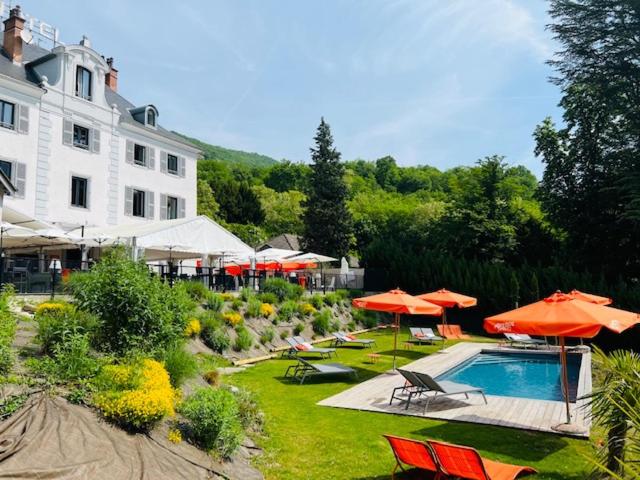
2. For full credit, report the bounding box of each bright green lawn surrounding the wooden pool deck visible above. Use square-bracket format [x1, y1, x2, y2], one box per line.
[226, 331, 593, 480]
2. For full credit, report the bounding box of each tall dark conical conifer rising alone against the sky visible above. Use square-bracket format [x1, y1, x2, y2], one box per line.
[303, 118, 353, 258]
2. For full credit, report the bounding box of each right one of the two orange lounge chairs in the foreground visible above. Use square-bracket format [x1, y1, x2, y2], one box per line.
[427, 440, 536, 480]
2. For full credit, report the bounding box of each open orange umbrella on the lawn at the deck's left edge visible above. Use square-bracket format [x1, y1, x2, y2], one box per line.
[352, 289, 442, 370]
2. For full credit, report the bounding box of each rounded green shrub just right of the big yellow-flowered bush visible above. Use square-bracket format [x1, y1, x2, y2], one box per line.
[180, 387, 244, 457]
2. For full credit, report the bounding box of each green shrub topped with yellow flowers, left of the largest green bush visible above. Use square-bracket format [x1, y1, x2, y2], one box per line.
[34, 303, 98, 354]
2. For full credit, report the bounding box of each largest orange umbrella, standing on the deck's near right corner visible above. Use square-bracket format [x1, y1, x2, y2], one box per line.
[484, 292, 640, 432]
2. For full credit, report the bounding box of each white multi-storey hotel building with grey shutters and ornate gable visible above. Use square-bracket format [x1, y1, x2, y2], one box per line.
[0, 5, 200, 234]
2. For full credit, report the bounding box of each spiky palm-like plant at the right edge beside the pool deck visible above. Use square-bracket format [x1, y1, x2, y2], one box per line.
[589, 348, 640, 478]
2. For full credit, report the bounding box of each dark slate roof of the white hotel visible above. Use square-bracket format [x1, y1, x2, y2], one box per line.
[0, 39, 198, 149]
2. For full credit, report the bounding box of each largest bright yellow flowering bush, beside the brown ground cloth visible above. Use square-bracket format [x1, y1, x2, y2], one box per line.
[94, 359, 179, 429]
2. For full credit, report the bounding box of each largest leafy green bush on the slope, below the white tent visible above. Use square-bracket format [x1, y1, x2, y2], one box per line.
[69, 248, 193, 353]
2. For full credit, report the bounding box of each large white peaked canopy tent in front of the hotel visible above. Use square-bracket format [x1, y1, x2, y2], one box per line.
[73, 215, 253, 261]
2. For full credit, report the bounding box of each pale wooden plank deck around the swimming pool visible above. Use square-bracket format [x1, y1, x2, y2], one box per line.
[318, 342, 591, 437]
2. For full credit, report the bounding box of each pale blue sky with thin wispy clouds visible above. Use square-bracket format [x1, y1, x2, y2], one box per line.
[14, 0, 561, 176]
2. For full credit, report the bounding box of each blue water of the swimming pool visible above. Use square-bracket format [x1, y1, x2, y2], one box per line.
[437, 352, 582, 402]
